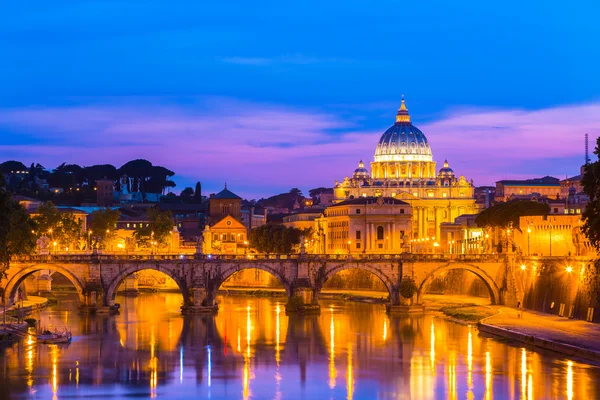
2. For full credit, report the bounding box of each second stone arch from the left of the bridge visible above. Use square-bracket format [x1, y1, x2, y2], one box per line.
[102, 264, 191, 306]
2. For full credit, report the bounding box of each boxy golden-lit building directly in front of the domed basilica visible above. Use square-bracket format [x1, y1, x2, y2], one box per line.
[311, 196, 411, 254]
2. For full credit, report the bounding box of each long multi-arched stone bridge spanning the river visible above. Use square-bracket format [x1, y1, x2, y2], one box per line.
[0, 253, 568, 313]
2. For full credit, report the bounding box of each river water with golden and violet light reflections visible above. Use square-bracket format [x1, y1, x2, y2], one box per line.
[0, 293, 600, 400]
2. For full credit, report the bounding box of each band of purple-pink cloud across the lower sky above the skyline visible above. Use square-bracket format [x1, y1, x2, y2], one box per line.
[0, 97, 600, 198]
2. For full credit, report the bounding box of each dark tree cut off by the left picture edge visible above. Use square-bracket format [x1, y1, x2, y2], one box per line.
[0, 174, 36, 278]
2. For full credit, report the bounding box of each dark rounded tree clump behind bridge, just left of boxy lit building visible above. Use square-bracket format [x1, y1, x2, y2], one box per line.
[250, 224, 302, 254]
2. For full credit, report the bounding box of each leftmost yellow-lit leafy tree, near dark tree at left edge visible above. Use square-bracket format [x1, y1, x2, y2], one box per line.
[33, 201, 82, 250]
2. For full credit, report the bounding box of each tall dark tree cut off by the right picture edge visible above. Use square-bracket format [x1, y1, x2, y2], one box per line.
[581, 138, 600, 250]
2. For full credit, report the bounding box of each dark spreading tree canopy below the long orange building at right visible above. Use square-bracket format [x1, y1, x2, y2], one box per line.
[475, 200, 550, 227]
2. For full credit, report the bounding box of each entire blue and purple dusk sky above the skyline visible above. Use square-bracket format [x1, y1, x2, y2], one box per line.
[0, 0, 600, 197]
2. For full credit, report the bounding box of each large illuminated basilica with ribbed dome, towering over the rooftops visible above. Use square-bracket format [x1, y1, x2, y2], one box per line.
[334, 100, 479, 241]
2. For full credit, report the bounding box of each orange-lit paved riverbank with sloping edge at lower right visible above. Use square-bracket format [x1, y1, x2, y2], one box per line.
[478, 307, 600, 363]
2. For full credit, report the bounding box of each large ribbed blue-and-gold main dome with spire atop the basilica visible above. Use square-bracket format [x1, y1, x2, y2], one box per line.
[375, 99, 433, 162]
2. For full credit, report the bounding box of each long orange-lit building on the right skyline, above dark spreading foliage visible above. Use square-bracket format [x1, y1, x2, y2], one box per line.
[495, 176, 561, 202]
